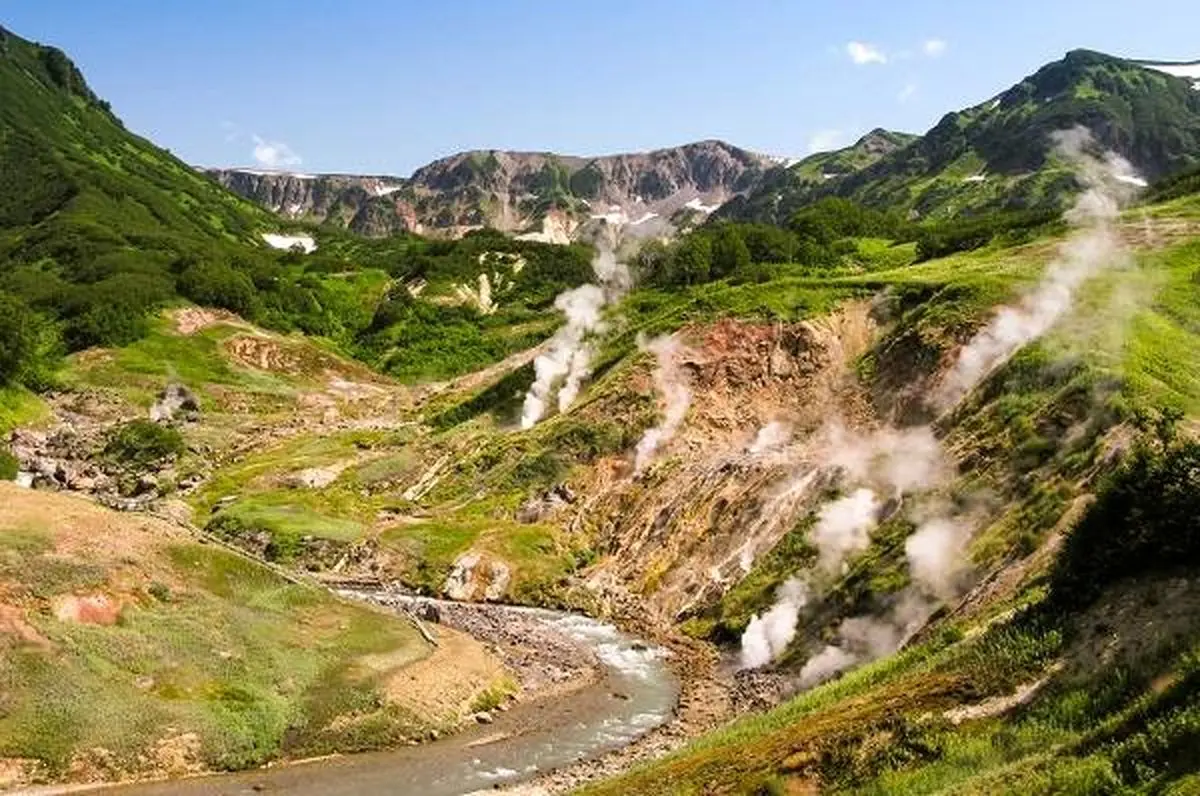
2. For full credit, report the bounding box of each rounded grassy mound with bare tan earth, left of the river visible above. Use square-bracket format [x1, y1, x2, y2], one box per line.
[0, 485, 428, 777]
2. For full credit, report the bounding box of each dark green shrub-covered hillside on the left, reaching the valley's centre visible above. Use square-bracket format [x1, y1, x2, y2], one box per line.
[0, 30, 590, 405]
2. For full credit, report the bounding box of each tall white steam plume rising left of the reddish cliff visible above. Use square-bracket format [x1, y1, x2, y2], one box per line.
[521, 243, 630, 429]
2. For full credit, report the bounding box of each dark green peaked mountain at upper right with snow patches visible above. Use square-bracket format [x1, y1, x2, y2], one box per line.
[721, 49, 1200, 222]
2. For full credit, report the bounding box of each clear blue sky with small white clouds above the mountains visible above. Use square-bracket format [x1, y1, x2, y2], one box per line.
[0, 0, 1200, 174]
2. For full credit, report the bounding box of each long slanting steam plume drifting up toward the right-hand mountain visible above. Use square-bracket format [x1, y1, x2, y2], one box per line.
[935, 127, 1145, 411]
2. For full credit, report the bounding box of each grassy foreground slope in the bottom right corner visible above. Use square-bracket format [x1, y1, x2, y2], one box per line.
[581, 597, 1200, 796]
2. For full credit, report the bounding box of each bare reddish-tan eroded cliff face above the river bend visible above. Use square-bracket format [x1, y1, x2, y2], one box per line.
[561, 303, 876, 622]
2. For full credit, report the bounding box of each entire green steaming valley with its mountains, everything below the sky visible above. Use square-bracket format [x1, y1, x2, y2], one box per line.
[0, 17, 1200, 795]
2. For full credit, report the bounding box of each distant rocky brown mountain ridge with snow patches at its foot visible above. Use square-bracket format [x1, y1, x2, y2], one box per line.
[208, 140, 781, 243]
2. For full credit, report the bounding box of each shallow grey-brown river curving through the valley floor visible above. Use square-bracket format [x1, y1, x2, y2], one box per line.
[98, 593, 679, 796]
